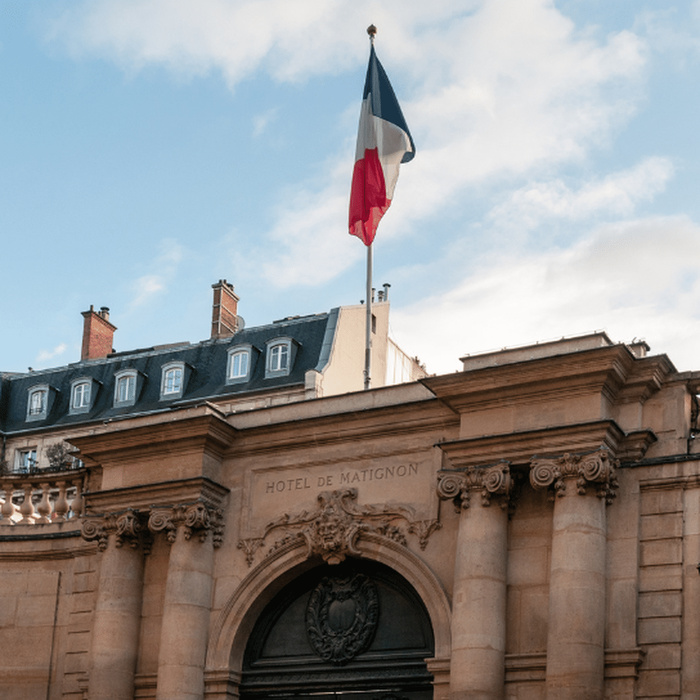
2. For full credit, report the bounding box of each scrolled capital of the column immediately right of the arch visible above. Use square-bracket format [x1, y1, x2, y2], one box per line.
[437, 462, 513, 512]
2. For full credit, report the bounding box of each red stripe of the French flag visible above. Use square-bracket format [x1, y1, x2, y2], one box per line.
[350, 148, 391, 246]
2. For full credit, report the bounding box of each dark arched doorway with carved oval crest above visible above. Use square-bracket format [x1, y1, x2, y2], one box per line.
[240, 559, 434, 700]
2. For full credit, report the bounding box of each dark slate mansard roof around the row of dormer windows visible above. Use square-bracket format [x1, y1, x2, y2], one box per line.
[0, 309, 339, 435]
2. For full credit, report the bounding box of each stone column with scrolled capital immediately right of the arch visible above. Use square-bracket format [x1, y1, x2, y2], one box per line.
[438, 463, 511, 700]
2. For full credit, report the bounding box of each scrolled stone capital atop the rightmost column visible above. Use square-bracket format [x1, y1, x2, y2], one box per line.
[530, 449, 617, 504]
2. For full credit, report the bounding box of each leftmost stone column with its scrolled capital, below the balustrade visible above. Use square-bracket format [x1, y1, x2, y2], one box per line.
[82, 510, 147, 700]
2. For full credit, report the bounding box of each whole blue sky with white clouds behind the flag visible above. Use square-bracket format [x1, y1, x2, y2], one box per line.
[0, 0, 700, 373]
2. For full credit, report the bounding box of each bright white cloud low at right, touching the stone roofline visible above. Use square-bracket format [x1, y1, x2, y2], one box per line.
[392, 217, 700, 373]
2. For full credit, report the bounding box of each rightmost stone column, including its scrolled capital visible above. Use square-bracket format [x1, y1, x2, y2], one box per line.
[530, 450, 616, 700]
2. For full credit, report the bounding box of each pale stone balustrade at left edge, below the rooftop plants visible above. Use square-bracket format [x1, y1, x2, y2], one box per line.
[0, 469, 87, 527]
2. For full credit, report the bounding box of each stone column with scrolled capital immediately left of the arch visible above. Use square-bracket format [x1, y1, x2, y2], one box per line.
[149, 503, 218, 700]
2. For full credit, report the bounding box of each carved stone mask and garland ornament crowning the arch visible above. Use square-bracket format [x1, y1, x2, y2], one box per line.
[238, 488, 440, 566]
